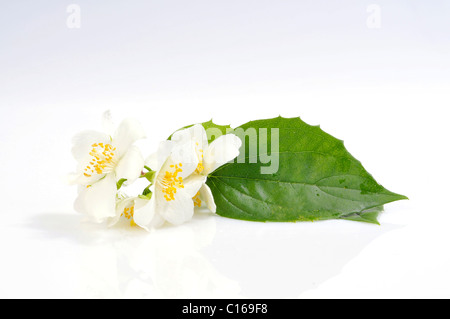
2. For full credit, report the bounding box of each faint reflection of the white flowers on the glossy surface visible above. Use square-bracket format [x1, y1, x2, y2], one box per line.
[80, 216, 239, 298]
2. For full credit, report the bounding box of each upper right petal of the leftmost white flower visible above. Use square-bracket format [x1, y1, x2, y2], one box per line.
[113, 119, 145, 157]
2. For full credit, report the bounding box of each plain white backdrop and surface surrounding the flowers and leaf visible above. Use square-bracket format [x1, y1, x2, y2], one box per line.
[0, 0, 450, 298]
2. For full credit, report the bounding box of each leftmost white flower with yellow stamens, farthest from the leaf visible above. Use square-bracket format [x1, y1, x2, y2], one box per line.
[71, 113, 145, 222]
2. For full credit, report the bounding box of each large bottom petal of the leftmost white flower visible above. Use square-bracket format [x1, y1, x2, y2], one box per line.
[75, 174, 117, 222]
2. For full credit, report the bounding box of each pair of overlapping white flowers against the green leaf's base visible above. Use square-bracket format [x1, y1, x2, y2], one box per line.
[134, 124, 242, 229]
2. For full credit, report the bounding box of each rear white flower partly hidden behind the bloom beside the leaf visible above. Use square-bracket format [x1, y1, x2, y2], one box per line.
[172, 124, 242, 213]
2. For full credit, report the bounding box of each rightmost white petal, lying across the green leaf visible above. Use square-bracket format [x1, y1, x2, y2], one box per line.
[203, 134, 242, 175]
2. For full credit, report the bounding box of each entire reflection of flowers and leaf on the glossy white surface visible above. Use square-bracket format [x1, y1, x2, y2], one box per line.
[26, 214, 395, 298]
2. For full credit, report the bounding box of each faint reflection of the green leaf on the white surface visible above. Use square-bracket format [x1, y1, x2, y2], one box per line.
[206, 221, 398, 298]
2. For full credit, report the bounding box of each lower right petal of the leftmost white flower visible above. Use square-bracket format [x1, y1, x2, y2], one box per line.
[115, 146, 144, 185]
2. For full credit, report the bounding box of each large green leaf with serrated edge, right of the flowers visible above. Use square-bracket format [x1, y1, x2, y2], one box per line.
[207, 117, 407, 224]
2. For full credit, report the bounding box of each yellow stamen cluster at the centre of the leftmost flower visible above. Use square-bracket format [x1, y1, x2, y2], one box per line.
[84, 143, 116, 177]
